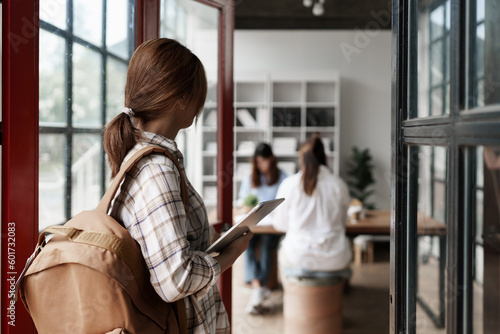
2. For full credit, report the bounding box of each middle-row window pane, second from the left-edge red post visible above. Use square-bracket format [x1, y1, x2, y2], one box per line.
[73, 44, 102, 127]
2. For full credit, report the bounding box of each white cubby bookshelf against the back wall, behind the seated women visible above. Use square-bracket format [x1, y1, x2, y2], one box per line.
[190, 72, 340, 212]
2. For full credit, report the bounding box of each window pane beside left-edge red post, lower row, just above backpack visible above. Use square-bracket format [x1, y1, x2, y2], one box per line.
[38, 134, 66, 230]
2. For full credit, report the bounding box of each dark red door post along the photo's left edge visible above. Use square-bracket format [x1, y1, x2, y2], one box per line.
[1, 0, 38, 334]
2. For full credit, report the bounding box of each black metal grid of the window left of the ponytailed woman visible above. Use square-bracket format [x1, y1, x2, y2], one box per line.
[39, 0, 135, 223]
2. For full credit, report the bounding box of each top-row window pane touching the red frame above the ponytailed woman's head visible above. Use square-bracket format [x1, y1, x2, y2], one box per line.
[106, 0, 130, 58]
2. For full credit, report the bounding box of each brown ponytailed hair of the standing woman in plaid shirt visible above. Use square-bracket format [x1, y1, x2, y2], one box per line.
[104, 38, 207, 177]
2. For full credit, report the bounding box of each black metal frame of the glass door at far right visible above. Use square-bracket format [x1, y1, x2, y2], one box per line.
[389, 0, 500, 334]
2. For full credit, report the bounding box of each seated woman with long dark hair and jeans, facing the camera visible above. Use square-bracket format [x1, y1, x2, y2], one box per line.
[238, 143, 286, 314]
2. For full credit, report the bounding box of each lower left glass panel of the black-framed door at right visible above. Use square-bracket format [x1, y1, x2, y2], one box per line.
[406, 146, 447, 334]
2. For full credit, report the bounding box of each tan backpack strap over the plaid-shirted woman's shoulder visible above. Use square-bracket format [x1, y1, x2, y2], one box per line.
[96, 146, 189, 214]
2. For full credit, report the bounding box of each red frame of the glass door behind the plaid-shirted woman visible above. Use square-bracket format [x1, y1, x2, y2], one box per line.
[137, 0, 234, 321]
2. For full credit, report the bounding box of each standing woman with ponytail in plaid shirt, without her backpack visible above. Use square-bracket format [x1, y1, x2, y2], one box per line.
[104, 38, 252, 333]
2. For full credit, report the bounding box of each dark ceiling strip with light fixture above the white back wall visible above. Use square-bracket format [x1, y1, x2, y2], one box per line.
[235, 0, 392, 29]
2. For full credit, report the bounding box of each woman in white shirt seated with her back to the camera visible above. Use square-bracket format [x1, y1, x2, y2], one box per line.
[273, 134, 352, 272]
